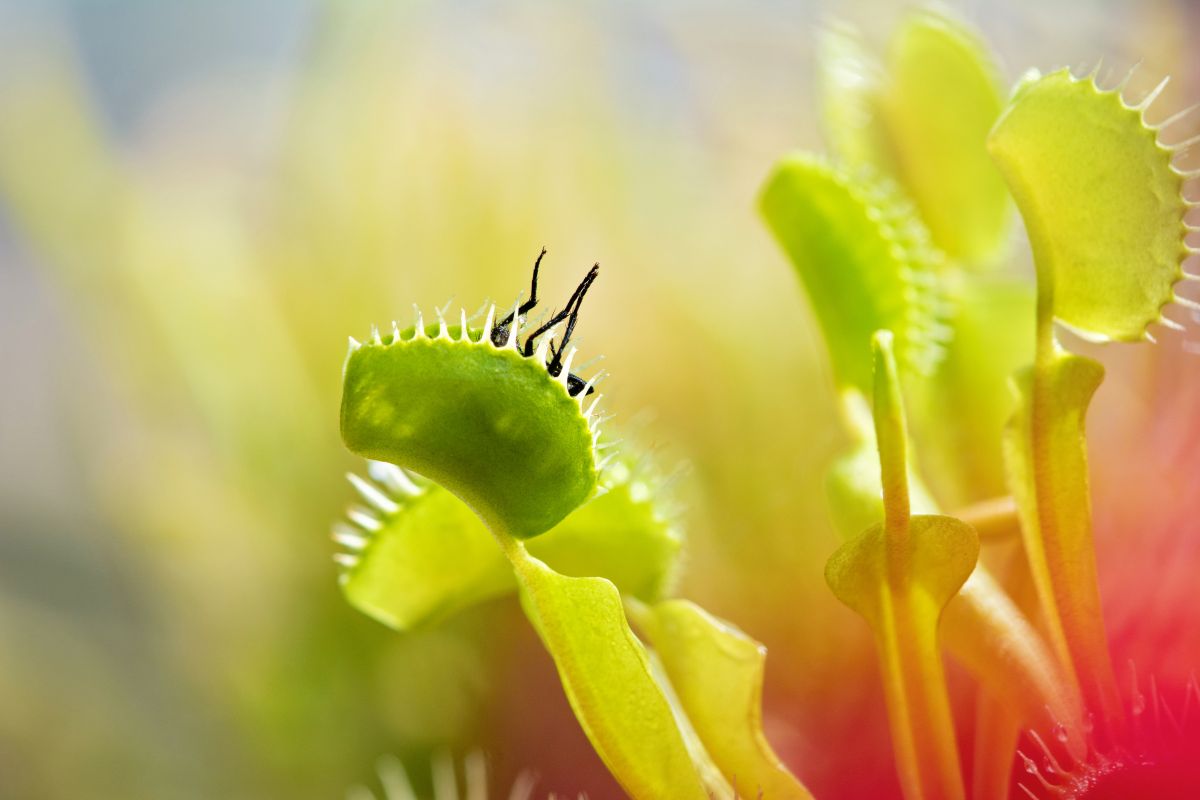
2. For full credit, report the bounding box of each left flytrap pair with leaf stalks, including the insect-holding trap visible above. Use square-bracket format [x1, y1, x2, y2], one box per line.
[334, 258, 809, 799]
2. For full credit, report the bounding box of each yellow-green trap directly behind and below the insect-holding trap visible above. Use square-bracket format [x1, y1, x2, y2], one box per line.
[334, 455, 683, 631]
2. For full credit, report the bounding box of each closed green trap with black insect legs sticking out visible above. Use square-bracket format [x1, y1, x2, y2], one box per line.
[342, 307, 599, 539]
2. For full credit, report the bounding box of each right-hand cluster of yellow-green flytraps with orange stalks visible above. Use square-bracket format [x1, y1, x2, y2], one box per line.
[761, 12, 1198, 800]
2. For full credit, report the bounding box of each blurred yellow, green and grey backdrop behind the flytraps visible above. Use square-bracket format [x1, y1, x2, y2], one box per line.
[0, 0, 1200, 799]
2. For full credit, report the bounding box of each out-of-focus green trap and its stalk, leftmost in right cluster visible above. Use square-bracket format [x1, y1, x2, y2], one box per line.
[761, 109, 1084, 786]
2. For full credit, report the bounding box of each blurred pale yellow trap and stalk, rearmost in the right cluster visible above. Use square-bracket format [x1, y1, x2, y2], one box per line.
[816, 11, 1033, 507]
